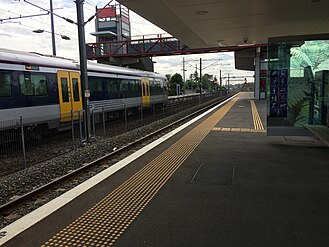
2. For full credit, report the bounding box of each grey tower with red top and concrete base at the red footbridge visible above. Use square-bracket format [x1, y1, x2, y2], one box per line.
[87, 4, 154, 71]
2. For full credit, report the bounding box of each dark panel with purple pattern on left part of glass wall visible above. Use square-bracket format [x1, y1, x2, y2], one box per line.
[270, 69, 288, 117]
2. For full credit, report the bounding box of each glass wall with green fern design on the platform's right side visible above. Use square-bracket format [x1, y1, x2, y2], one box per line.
[267, 37, 329, 134]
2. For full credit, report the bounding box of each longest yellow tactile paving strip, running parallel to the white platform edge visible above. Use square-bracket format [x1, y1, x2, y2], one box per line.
[42, 94, 241, 247]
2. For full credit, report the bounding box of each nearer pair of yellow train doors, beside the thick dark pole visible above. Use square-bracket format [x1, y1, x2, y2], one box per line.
[57, 71, 82, 122]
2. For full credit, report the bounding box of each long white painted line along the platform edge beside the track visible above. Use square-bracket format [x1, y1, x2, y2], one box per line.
[0, 94, 237, 245]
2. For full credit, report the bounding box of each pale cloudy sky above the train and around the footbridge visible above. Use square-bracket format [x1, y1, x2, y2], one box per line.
[0, 0, 254, 84]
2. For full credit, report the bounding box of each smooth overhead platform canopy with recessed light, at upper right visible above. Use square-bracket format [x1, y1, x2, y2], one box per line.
[118, 0, 329, 48]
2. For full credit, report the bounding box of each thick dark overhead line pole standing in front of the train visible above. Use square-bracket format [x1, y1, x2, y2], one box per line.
[75, 0, 91, 142]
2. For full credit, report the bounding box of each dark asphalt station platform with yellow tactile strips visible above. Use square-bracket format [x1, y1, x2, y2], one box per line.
[0, 93, 329, 247]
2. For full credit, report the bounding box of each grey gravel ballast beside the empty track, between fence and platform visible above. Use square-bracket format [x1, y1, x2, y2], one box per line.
[0, 97, 226, 228]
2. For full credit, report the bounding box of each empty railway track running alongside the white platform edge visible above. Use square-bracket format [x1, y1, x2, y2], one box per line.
[0, 96, 229, 226]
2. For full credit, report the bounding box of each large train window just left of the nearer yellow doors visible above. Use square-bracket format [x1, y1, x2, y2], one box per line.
[19, 73, 48, 96]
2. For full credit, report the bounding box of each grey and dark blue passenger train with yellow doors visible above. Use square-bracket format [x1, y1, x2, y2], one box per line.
[0, 49, 168, 129]
